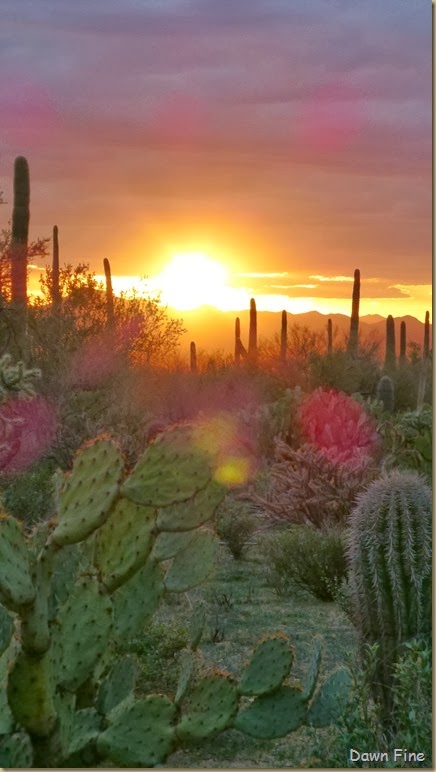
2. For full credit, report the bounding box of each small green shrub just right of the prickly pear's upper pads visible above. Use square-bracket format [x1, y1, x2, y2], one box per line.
[215, 496, 257, 560]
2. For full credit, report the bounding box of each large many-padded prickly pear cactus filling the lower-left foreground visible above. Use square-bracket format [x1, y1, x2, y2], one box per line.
[0, 426, 350, 767]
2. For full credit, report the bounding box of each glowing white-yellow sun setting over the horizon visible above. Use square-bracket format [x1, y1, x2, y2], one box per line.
[153, 252, 229, 311]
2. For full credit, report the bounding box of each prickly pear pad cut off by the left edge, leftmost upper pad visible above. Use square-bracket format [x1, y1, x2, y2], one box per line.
[0, 515, 35, 610]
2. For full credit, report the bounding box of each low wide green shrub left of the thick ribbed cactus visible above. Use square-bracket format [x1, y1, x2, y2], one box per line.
[261, 525, 347, 601]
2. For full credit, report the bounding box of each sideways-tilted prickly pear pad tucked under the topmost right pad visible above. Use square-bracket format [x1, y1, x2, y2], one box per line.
[157, 480, 226, 531]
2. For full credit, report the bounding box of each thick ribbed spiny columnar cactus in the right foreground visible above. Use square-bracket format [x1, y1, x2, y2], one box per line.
[348, 470, 432, 724]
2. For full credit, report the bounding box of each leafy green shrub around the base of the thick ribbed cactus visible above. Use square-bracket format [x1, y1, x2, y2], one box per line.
[311, 640, 433, 769]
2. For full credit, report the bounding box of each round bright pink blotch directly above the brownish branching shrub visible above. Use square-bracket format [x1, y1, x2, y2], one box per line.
[298, 388, 380, 467]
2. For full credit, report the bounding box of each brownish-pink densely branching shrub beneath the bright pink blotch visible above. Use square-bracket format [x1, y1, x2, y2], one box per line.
[252, 440, 378, 528]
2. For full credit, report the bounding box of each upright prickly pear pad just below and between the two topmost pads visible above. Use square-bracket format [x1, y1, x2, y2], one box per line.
[94, 498, 156, 592]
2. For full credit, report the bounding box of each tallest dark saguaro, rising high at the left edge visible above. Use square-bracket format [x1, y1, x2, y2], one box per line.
[11, 156, 30, 307]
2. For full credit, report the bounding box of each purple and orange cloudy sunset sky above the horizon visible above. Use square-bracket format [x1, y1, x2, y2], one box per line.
[0, 0, 432, 320]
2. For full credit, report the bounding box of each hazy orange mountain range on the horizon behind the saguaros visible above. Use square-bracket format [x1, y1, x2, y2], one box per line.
[168, 306, 432, 357]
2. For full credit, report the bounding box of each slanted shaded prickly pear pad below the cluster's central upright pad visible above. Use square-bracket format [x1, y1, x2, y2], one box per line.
[112, 558, 163, 640]
